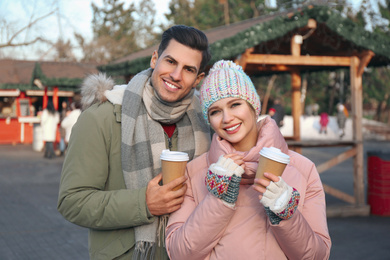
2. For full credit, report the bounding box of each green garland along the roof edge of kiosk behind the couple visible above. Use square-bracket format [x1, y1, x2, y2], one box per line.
[98, 6, 390, 76]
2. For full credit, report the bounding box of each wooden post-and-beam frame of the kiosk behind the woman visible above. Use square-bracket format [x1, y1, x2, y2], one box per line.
[236, 19, 375, 216]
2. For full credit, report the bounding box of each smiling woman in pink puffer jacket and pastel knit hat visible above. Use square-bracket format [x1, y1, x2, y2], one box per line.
[166, 61, 331, 260]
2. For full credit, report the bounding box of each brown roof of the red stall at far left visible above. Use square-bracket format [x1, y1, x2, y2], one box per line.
[0, 59, 98, 91]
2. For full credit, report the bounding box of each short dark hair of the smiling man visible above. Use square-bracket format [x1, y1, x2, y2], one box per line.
[158, 25, 211, 73]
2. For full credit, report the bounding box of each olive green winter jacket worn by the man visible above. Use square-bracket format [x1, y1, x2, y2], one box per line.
[58, 101, 177, 259]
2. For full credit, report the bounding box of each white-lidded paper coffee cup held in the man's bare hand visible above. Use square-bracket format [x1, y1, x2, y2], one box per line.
[160, 150, 189, 190]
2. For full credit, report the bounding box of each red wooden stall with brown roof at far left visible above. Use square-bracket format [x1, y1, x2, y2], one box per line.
[0, 59, 98, 147]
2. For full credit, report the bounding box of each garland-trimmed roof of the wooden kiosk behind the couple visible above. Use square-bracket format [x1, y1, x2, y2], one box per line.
[98, 6, 390, 76]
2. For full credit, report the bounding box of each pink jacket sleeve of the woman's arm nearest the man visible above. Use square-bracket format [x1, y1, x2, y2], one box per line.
[166, 164, 235, 260]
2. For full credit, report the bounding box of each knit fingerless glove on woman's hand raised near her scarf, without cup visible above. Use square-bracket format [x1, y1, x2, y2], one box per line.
[205, 155, 244, 205]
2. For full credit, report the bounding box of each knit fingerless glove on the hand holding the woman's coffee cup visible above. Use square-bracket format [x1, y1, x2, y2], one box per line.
[260, 177, 300, 224]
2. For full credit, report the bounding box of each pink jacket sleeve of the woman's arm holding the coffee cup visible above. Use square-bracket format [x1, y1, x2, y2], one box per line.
[271, 152, 331, 259]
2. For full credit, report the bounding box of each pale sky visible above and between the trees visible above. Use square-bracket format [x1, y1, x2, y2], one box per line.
[0, 0, 366, 60]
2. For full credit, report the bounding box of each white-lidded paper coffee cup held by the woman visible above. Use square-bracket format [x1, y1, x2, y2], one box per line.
[256, 147, 290, 184]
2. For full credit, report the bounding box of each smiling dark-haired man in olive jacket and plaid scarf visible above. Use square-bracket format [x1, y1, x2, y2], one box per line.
[58, 25, 210, 259]
